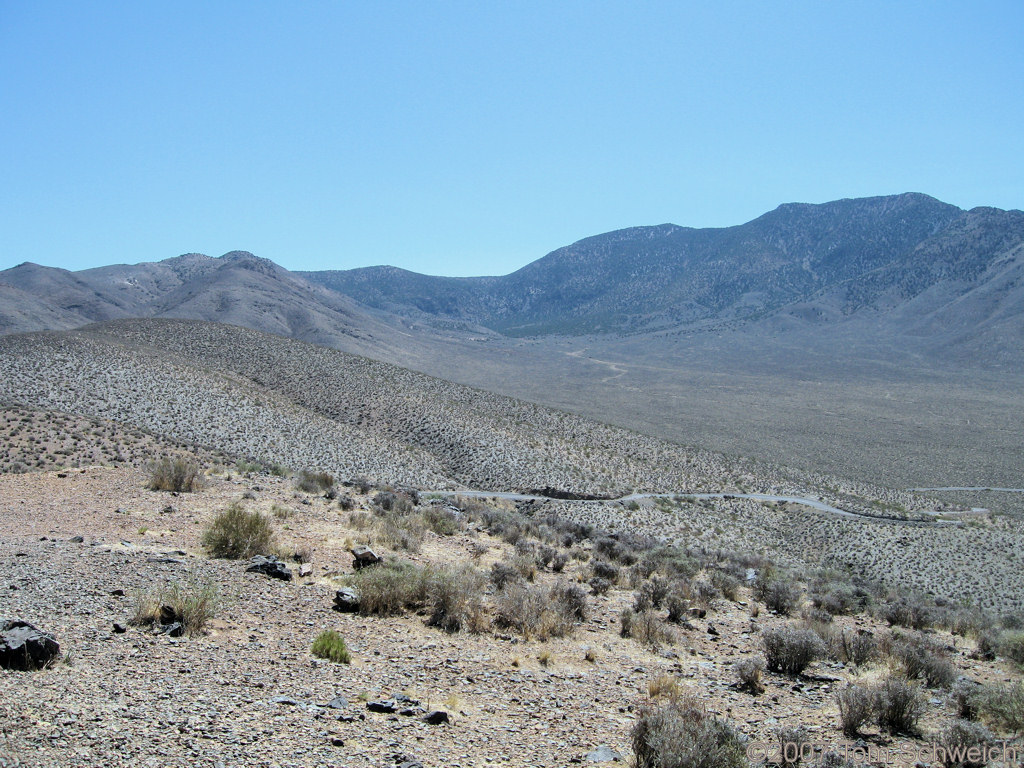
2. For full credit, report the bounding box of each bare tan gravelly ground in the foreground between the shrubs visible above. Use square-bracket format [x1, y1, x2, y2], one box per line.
[0, 467, 1020, 767]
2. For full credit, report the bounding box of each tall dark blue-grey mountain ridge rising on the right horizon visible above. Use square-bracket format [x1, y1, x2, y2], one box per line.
[303, 194, 1024, 336]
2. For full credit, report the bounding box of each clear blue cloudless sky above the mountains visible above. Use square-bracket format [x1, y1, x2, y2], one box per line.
[0, 0, 1024, 274]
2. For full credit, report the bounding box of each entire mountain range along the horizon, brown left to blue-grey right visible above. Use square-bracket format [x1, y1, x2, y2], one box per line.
[0, 194, 1024, 357]
